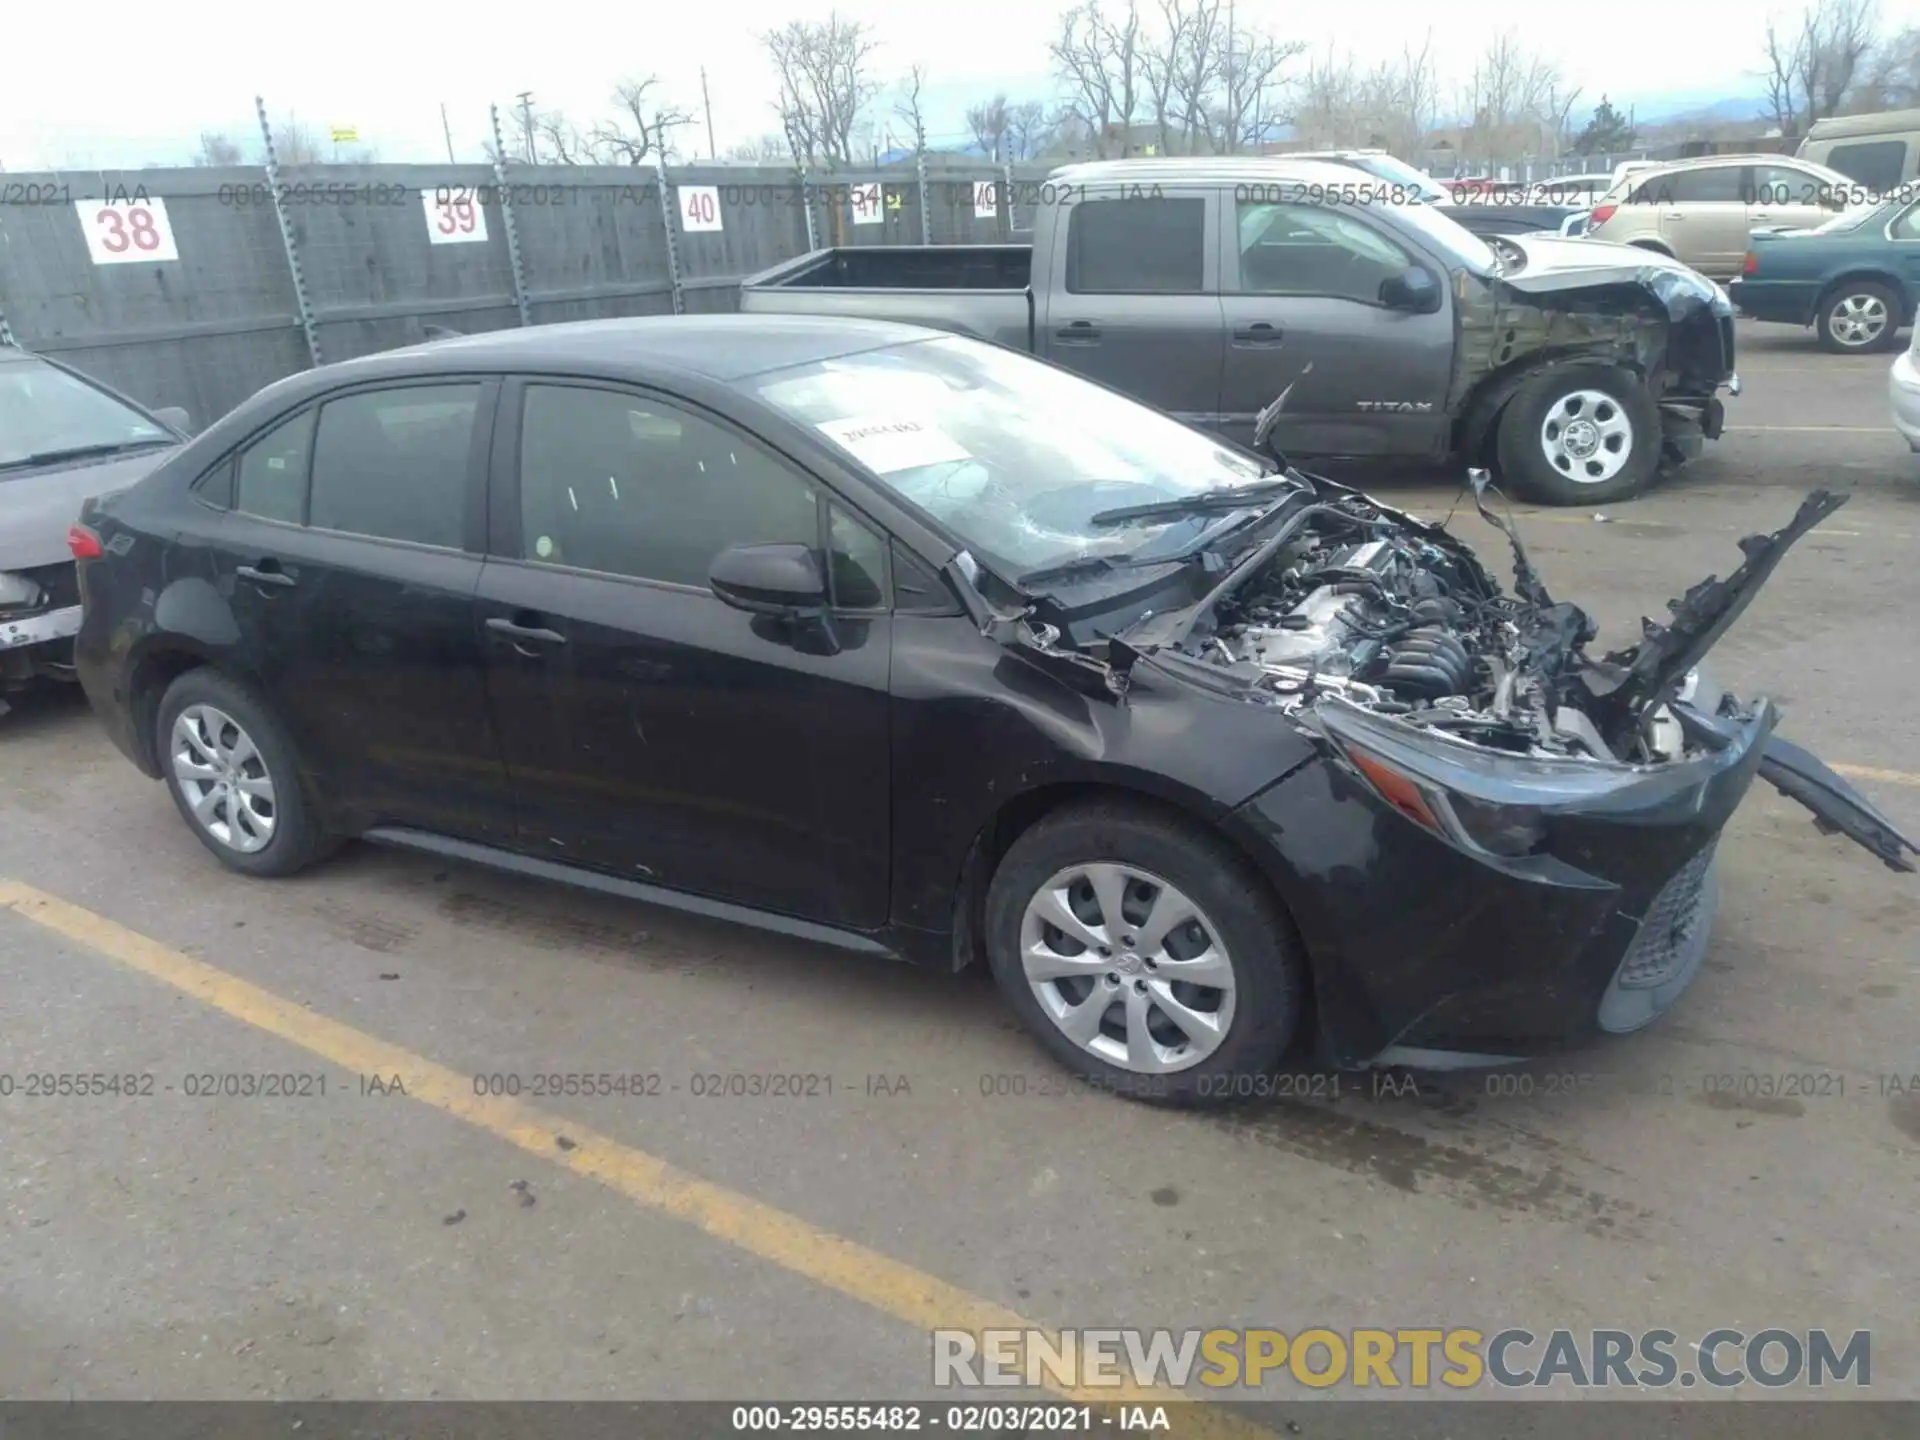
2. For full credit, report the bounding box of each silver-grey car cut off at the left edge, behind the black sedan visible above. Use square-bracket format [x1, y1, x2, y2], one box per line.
[0, 346, 190, 714]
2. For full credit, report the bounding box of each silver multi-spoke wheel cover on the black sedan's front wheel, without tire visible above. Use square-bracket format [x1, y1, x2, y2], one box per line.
[1020, 862, 1235, 1075]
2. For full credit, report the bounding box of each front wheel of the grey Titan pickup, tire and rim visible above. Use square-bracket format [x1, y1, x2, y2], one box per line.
[1498, 365, 1661, 505]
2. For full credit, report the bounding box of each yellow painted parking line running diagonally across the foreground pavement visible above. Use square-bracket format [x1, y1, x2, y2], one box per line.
[0, 881, 1273, 1440]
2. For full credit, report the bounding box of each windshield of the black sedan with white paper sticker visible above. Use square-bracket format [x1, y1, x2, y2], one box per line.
[756, 336, 1269, 578]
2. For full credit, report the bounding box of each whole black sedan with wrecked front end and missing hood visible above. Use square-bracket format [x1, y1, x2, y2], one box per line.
[71, 315, 1912, 1102]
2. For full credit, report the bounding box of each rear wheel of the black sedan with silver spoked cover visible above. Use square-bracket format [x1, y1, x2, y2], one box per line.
[154, 668, 330, 876]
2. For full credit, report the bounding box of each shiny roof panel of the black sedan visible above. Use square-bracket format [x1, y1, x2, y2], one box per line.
[326, 315, 945, 380]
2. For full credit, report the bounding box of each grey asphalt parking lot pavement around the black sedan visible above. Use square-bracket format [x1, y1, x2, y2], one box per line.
[0, 324, 1920, 1434]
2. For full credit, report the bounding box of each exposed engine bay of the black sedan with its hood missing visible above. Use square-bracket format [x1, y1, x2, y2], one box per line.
[1181, 481, 1686, 764]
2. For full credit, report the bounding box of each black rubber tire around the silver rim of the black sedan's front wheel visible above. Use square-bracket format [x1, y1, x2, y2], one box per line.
[987, 801, 1308, 1106]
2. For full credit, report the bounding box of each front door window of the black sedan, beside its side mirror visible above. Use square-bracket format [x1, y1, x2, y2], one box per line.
[520, 384, 821, 589]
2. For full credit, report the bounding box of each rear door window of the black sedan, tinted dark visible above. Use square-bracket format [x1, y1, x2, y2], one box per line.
[307, 384, 480, 549]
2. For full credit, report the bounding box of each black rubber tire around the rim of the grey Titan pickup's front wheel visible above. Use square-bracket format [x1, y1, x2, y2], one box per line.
[1498, 365, 1665, 505]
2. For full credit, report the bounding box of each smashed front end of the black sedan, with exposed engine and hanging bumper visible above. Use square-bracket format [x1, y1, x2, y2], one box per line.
[952, 470, 1920, 1066]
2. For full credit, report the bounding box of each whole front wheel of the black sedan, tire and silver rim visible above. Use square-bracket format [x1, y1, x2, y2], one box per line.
[987, 801, 1306, 1104]
